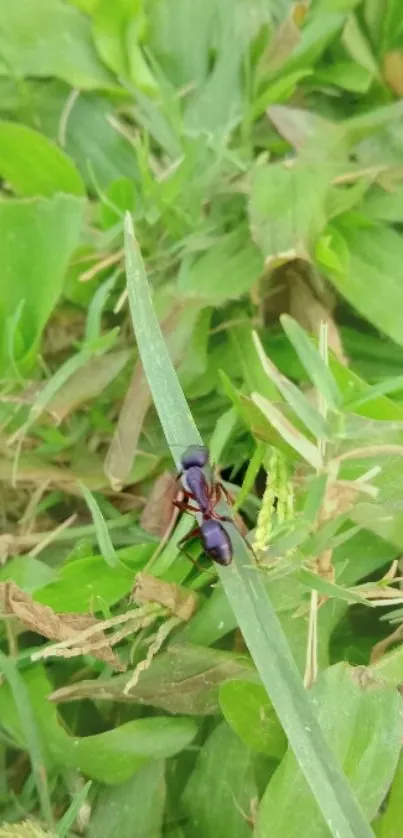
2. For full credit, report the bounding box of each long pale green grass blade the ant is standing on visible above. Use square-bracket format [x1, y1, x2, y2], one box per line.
[125, 214, 373, 838]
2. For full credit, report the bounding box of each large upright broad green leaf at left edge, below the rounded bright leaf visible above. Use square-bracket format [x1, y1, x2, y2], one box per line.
[0, 195, 84, 366]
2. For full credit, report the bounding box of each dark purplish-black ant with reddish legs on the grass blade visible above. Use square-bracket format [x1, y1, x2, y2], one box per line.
[174, 445, 233, 567]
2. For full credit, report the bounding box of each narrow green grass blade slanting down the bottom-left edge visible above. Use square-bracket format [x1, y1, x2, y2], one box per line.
[0, 651, 53, 826]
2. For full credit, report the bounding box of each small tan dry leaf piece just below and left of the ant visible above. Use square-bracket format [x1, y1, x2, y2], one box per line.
[132, 573, 197, 621]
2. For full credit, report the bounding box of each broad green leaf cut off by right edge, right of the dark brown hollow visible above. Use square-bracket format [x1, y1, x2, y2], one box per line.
[320, 221, 403, 346]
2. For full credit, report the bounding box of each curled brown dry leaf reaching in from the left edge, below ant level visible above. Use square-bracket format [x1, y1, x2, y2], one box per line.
[0, 582, 126, 672]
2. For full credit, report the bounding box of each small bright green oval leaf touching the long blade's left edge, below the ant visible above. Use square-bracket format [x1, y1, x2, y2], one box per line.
[220, 681, 287, 759]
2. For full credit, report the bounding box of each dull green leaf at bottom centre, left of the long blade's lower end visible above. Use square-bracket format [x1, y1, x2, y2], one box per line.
[182, 722, 257, 838]
